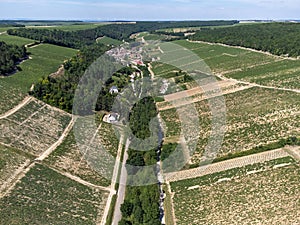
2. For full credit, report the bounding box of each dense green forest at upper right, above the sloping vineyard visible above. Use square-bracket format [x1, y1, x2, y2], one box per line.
[190, 23, 300, 57]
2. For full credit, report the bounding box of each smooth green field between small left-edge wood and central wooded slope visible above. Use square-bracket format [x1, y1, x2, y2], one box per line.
[0, 44, 76, 114]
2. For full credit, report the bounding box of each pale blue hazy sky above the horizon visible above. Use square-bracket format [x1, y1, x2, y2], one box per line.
[0, 0, 300, 20]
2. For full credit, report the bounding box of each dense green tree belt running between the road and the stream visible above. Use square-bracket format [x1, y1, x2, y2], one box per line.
[119, 97, 161, 225]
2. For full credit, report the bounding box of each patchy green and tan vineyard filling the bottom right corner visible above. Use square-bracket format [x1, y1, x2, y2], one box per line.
[171, 157, 300, 225]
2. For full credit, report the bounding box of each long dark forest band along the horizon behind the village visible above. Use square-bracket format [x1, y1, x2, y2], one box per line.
[7, 21, 238, 49]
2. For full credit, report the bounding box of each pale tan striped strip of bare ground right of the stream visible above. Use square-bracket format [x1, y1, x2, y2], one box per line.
[164, 148, 291, 182]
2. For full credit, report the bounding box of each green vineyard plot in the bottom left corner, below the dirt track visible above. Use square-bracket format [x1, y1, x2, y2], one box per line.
[0, 164, 108, 225]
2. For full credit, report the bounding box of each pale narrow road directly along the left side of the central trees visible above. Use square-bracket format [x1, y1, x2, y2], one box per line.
[112, 139, 130, 225]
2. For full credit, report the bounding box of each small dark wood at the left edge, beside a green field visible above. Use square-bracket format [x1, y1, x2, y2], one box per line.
[0, 41, 27, 76]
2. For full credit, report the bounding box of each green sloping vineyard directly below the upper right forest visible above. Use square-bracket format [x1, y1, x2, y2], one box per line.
[174, 41, 300, 89]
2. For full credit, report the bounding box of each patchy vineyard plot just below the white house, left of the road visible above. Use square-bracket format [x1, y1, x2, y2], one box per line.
[46, 118, 118, 187]
